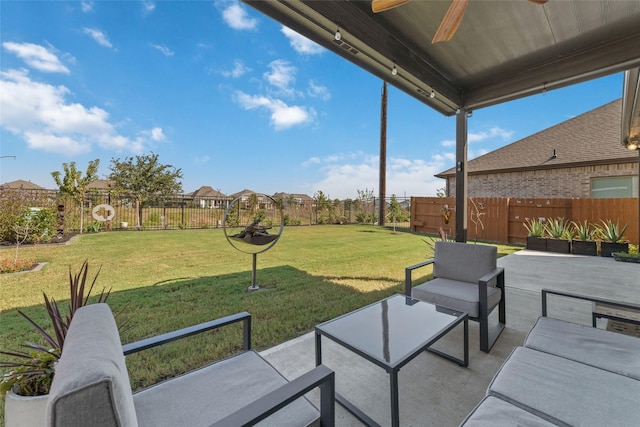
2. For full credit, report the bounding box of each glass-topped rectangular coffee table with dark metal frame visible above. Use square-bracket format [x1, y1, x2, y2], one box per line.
[316, 295, 469, 427]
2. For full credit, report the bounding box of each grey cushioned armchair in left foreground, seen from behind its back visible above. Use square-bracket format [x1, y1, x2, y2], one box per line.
[47, 303, 335, 427]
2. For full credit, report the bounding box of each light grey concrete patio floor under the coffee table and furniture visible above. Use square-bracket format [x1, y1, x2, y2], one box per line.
[261, 250, 640, 427]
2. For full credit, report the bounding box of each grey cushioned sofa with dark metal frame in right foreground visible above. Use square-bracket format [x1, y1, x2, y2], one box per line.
[461, 289, 640, 427]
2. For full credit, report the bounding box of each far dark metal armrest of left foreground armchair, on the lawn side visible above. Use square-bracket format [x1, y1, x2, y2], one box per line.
[122, 311, 251, 356]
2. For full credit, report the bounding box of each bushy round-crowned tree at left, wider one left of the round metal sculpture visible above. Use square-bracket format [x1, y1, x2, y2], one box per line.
[109, 152, 182, 228]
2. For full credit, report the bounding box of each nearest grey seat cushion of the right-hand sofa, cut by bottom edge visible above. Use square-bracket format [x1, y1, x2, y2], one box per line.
[460, 396, 555, 427]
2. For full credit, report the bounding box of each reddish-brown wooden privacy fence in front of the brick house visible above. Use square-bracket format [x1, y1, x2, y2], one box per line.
[411, 197, 638, 245]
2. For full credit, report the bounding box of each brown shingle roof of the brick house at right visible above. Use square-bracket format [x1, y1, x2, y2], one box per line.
[435, 99, 638, 178]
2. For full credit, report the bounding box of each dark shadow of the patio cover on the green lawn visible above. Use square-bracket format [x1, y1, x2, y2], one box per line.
[2, 266, 402, 389]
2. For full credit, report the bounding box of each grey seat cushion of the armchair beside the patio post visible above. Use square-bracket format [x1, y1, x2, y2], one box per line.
[411, 278, 502, 318]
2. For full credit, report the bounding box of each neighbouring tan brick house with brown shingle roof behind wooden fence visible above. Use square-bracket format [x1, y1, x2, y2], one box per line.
[436, 100, 638, 198]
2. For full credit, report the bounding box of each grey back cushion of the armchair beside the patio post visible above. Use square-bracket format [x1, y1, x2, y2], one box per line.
[433, 242, 498, 284]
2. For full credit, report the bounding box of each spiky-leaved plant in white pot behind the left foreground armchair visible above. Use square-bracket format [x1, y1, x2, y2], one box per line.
[0, 261, 111, 427]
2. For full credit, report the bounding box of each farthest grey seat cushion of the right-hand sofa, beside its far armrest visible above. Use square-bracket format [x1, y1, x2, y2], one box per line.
[524, 317, 640, 380]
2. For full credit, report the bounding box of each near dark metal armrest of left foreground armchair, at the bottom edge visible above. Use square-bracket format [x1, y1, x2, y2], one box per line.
[212, 365, 335, 427]
